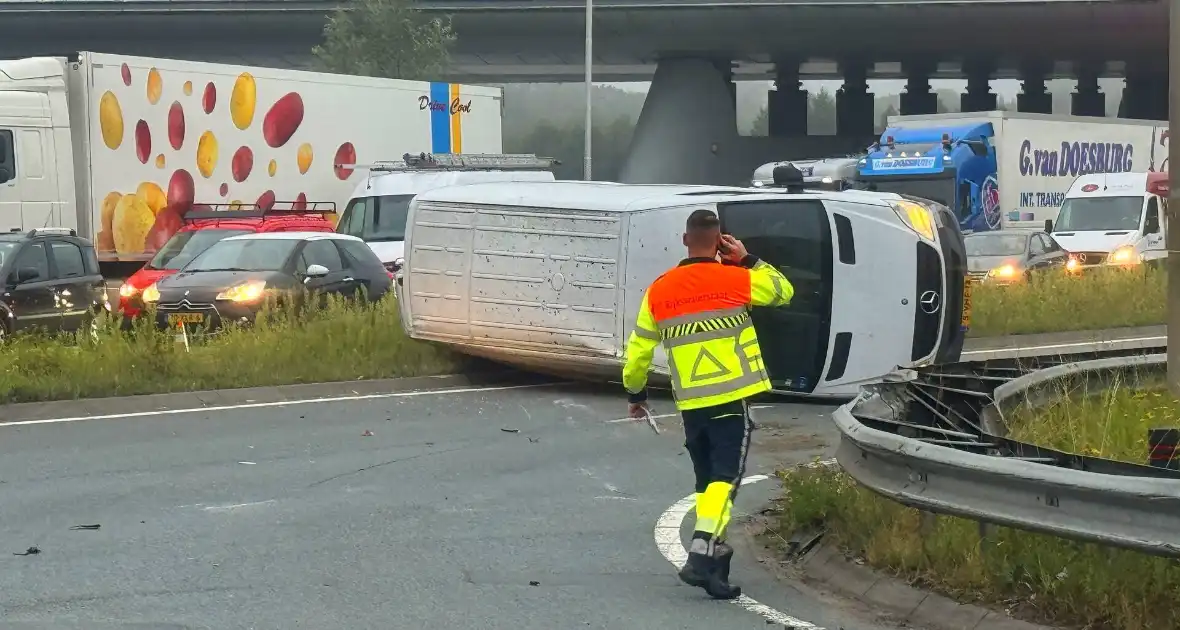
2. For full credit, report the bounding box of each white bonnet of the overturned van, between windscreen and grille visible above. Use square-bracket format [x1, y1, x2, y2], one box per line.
[814, 201, 918, 395]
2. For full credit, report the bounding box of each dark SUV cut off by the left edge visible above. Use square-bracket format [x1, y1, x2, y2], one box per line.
[0, 228, 111, 340]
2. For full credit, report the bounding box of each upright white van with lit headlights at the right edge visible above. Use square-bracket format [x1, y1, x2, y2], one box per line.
[1045, 172, 1168, 267]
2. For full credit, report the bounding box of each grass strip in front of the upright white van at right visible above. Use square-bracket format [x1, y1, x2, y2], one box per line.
[969, 267, 1167, 337]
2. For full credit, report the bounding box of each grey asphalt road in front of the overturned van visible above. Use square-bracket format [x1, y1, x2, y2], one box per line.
[0, 386, 901, 630]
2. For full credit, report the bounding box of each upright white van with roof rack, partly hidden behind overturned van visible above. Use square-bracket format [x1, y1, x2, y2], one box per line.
[336, 153, 558, 271]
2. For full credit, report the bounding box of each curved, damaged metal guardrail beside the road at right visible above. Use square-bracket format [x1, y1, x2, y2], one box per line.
[833, 347, 1180, 557]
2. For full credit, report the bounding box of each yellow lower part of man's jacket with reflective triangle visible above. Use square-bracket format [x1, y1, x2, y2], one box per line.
[658, 308, 767, 400]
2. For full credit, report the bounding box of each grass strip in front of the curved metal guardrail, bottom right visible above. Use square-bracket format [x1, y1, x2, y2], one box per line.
[766, 468, 1180, 630]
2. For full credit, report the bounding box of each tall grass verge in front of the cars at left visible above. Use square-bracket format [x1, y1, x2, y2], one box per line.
[0, 298, 464, 403]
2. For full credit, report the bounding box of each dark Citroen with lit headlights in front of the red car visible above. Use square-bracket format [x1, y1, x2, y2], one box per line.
[143, 232, 392, 333]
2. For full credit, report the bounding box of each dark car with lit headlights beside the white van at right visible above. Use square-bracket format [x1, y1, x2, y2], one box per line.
[963, 230, 1077, 284]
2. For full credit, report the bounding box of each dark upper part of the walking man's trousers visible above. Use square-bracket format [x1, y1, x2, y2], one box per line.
[681, 400, 754, 492]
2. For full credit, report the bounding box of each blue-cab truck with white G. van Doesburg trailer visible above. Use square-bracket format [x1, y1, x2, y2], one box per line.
[857, 112, 1168, 231]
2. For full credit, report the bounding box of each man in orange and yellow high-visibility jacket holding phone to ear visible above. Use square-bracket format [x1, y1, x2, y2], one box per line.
[623, 210, 794, 599]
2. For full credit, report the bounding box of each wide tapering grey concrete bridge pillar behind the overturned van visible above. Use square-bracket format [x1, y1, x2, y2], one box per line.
[618, 58, 736, 185]
